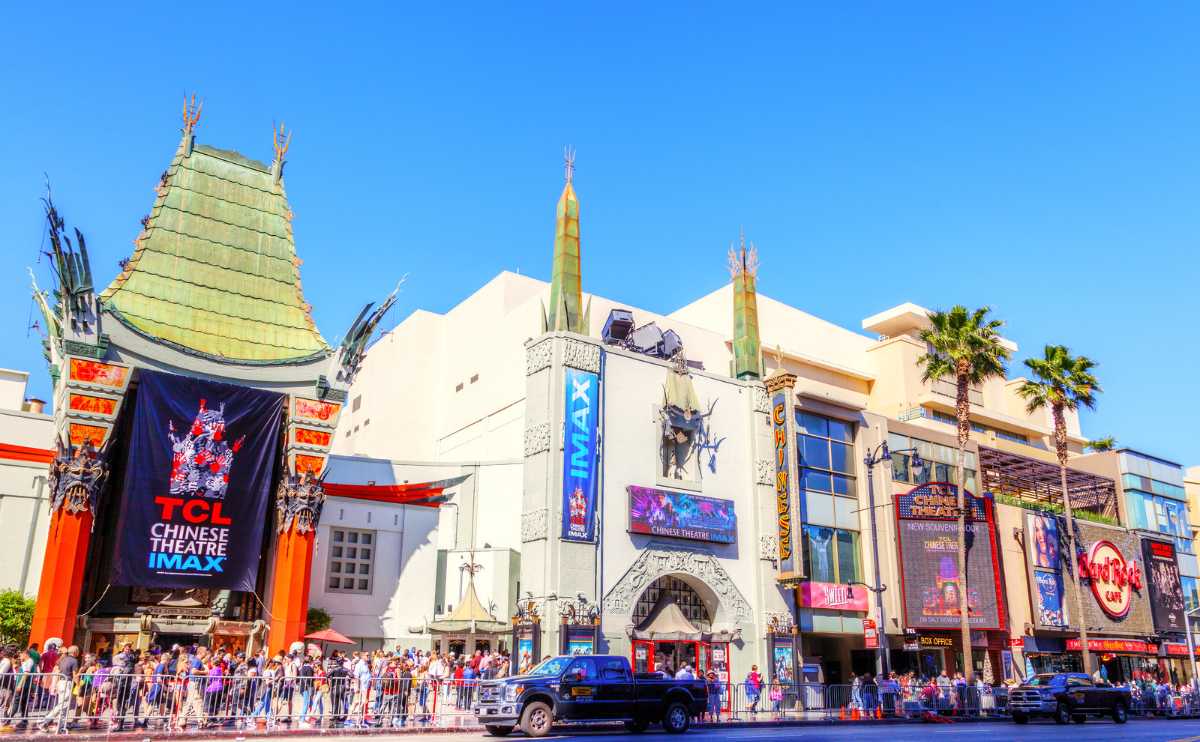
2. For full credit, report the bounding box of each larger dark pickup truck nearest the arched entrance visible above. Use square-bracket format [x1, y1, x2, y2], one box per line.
[474, 654, 708, 737]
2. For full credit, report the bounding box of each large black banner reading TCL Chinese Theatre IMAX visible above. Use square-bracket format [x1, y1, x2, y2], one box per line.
[113, 371, 283, 591]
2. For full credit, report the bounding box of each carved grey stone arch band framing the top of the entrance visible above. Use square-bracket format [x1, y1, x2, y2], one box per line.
[604, 544, 752, 623]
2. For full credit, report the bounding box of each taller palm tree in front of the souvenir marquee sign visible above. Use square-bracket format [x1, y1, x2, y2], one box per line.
[917, 305, 1008, 682]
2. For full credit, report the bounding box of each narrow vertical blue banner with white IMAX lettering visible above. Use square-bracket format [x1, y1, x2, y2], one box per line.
[563, 369, 600, 541]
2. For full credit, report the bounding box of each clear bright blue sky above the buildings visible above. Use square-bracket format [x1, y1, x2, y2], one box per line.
[0, 2, 1200, 463]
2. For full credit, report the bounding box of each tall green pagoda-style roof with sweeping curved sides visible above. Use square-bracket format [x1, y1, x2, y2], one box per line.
[101, 131, 330, 364]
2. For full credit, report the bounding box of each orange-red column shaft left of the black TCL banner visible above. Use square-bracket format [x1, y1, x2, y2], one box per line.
[29, 508, 91, 646]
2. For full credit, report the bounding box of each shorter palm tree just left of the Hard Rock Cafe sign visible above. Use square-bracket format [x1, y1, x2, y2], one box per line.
[1018, 346, 1099, 672]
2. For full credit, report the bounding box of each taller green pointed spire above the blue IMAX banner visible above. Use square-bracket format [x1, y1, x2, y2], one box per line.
[542, 146, 592, 335]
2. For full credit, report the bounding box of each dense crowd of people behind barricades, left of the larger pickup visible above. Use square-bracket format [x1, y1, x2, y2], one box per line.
[0, 644, 509, 731]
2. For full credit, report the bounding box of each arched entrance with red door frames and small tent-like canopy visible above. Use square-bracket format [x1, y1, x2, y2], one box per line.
[632, 575, 731, 707]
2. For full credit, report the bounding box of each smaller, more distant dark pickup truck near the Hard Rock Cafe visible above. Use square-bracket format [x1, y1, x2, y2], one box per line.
[1008, 672, 1132, 724]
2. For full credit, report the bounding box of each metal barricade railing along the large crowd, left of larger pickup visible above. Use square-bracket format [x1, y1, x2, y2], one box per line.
[0, 671, 480, 732]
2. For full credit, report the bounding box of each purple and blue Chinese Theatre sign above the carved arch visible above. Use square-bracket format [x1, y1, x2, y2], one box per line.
[629, 486, 738, 544]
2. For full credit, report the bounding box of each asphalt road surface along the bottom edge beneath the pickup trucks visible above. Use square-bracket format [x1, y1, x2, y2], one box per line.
[280, 719, 1200, 742]
